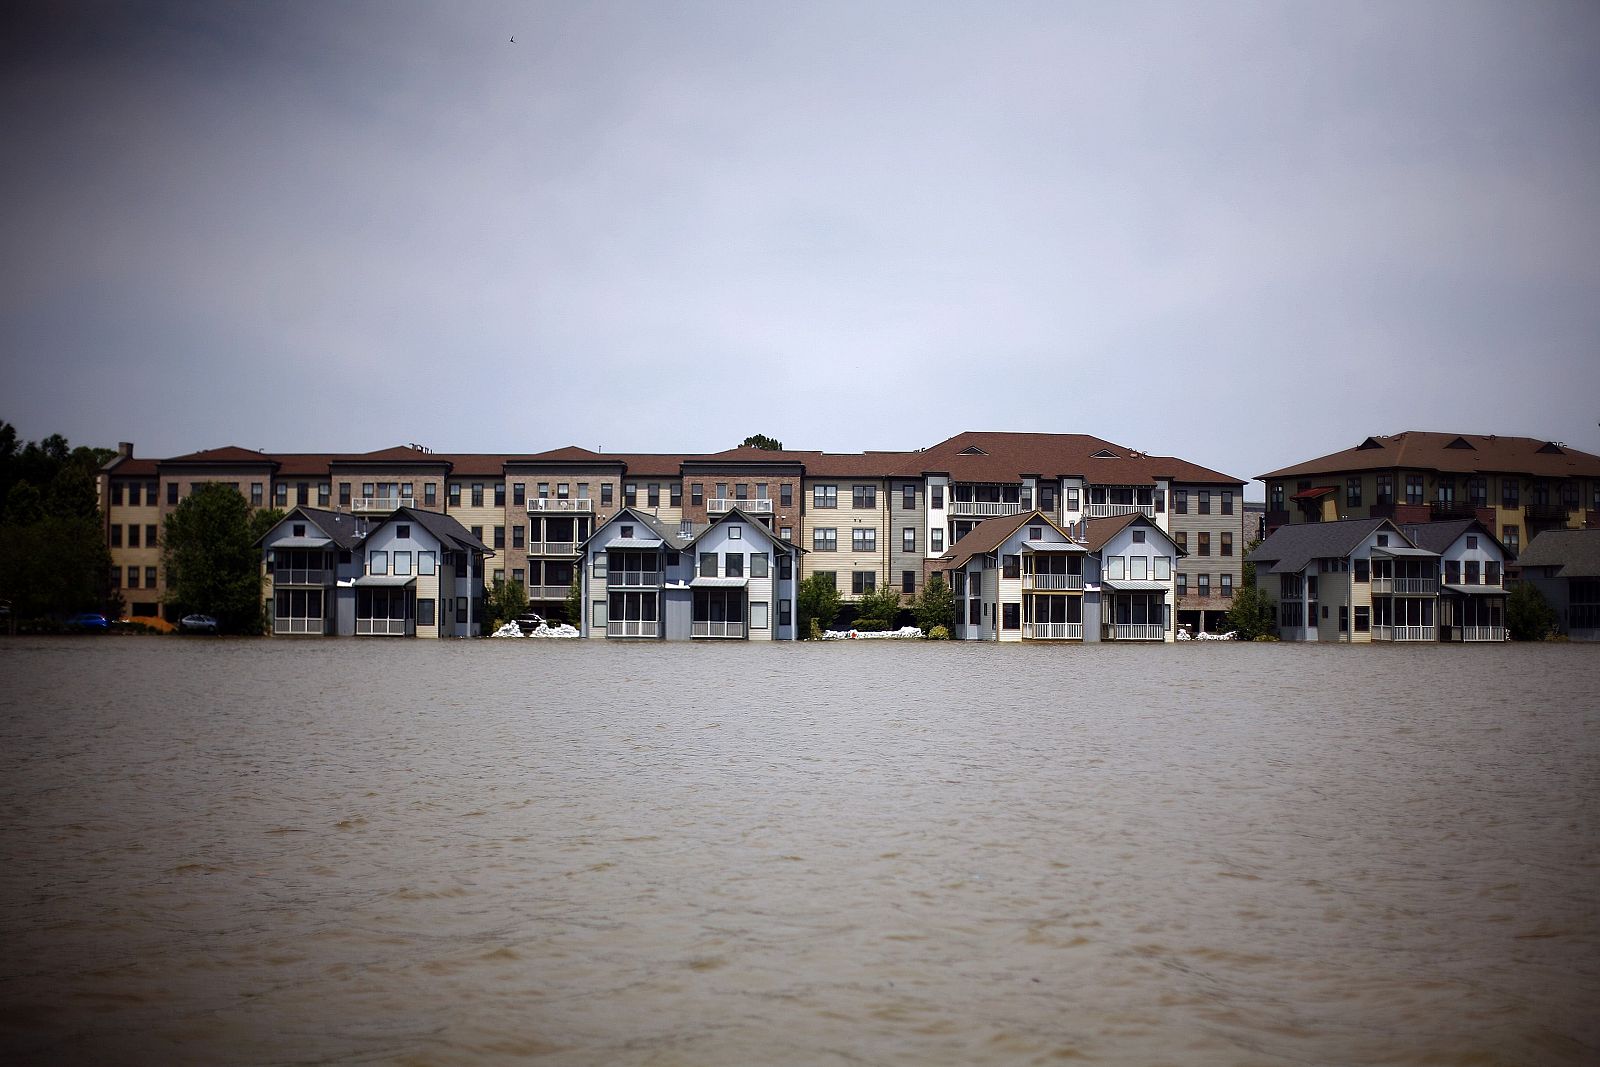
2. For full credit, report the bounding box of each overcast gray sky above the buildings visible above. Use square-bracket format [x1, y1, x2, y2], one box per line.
[0, 0, 1600, 496]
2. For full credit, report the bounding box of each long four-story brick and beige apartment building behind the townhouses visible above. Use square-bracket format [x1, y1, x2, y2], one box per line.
[101, 432, 1245, 633]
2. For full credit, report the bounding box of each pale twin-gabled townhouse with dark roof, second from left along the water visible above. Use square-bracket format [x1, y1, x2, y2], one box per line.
[579, 507, 800, 641]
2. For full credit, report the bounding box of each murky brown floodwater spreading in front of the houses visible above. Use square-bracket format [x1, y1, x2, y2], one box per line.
[0, 638, 1600, 1065]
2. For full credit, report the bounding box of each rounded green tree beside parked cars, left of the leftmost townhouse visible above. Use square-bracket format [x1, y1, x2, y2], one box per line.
[162, 482, 270, 633]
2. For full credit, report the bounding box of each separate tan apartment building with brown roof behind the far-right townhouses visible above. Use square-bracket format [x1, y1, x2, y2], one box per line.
[1259, 430, 1600, 560]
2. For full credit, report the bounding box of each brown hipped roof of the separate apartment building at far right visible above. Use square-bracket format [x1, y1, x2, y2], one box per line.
[1258, 430, 1600, 480]
